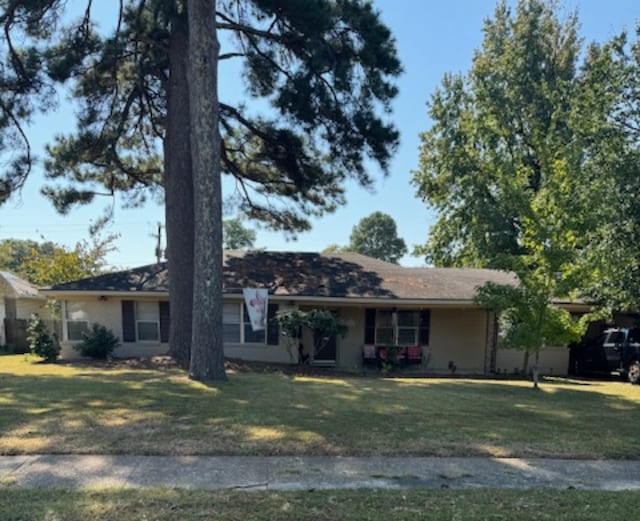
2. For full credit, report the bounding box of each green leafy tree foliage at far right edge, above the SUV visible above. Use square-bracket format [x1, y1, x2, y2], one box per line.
[575, 31, 640, 314]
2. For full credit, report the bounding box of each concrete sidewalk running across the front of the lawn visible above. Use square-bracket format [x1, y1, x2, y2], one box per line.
[0, 455, 640, 490]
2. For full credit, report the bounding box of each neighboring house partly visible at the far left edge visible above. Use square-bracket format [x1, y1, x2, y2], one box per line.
[0, 271, 51, 349]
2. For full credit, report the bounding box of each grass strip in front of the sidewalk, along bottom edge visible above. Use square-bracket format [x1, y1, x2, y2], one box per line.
[0, 489, 640, 521]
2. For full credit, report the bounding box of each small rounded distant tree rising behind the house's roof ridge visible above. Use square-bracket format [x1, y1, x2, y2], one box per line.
[346, 212, 407, 264]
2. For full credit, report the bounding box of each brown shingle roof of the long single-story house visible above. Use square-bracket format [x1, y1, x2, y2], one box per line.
[50, 251, 516, 301]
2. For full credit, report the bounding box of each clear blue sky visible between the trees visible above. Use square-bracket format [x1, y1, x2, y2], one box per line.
[0, 0, 640, 267]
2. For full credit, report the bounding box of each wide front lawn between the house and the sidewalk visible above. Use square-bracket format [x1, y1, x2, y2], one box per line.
[0, 356, 640, 458]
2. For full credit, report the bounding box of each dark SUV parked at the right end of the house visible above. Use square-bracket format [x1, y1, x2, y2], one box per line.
[571, 327, 640, 384]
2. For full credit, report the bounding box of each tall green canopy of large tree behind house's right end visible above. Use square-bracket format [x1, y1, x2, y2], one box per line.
[413, 0, 582, 267]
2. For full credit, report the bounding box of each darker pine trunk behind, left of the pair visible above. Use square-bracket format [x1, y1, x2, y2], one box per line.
[164, 14, 193, 370]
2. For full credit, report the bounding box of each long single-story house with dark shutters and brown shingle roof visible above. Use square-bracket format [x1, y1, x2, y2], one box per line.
[42, 251, 588, 374]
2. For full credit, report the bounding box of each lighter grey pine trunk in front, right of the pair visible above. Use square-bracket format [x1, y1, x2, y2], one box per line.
[187, 0, 226, 381]
